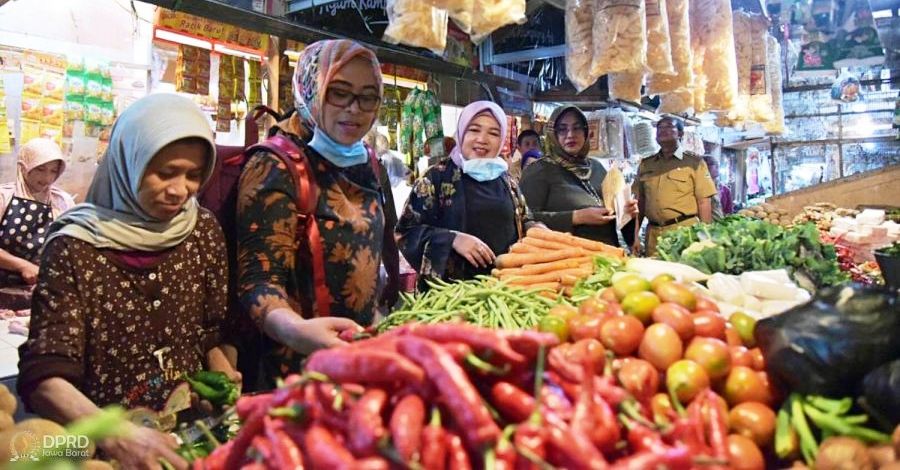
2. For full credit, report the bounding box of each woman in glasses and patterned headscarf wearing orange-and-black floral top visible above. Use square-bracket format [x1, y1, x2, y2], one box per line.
[238, 40, 399, 386]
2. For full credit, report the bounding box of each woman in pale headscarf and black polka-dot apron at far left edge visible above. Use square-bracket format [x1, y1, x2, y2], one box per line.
[0, 138, 75, 286]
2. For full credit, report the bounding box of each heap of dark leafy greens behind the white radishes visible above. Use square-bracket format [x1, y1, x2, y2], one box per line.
[657, 216, 849, 287]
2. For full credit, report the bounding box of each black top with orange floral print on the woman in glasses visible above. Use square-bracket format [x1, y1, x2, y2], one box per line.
[237, 139, 385, 379]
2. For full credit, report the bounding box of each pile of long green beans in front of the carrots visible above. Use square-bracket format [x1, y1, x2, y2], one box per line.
[378, 276, 556, 333]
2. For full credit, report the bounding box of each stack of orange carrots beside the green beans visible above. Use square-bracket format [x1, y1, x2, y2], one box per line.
[493, 228, 625, 294]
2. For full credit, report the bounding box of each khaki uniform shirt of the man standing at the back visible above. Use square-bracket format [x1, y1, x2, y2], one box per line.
[633, 151, 718, 224]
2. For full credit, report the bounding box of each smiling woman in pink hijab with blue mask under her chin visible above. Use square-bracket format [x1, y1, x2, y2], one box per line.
[397, 101, 530, 279]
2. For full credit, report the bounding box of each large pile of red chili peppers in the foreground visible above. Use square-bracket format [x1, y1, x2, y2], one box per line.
[194, 323, 752, 470]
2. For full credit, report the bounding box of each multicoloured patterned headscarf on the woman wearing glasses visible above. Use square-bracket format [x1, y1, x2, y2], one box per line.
[293, 39, 384, 136]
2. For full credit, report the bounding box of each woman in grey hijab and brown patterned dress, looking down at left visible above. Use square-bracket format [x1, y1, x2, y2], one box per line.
[17, 94, 240, 469]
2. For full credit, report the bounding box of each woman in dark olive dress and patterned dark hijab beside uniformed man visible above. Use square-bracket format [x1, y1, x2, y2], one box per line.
[520, 106, 638, 246]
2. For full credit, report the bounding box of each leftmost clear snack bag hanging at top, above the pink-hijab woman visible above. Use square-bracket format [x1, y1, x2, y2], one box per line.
[383, 0, 447, 55]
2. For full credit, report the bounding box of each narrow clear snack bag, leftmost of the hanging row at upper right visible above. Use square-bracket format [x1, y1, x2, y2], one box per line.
[566, 0, 600, 93]
